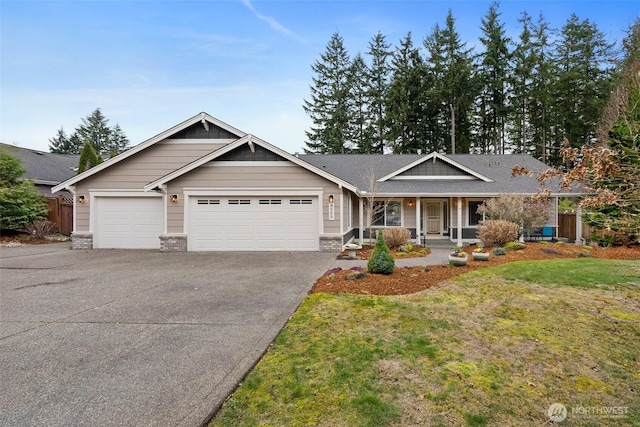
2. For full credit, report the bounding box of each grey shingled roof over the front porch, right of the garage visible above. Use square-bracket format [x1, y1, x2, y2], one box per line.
[299, 153, 566, 197]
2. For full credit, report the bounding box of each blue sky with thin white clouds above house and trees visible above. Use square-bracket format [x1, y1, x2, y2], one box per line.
[0, 0, 640, 153]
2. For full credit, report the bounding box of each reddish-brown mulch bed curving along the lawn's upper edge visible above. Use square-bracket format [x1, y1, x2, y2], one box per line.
[309, 243, 640, 295]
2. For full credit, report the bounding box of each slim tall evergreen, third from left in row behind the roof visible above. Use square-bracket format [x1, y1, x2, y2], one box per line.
[358, 32, 391, 154]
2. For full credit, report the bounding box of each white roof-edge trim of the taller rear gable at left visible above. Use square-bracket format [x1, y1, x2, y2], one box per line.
[51, 112, 247, 193]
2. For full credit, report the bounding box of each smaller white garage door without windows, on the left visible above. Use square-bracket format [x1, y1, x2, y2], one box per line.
[93, 197, 163, 249]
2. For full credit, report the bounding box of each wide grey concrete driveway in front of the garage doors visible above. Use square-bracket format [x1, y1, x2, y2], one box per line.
[0, 243, 335, 426]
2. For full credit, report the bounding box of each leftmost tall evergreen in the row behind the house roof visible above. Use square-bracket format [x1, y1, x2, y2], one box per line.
[303, 33, 351, 154]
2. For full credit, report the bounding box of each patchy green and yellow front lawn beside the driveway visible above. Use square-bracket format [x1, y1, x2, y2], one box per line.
[212, 259, 640, 426]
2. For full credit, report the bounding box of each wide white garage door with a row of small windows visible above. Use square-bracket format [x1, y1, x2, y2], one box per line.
[187, 196, 319, 251]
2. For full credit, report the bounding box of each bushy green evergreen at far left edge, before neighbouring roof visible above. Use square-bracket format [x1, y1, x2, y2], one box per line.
[0, 149, 48, 230]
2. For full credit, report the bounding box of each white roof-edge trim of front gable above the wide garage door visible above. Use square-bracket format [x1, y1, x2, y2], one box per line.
[144, 134, 357, 192]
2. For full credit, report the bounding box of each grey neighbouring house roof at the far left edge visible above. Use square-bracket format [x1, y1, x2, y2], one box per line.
[0, 143, 80, 186]
